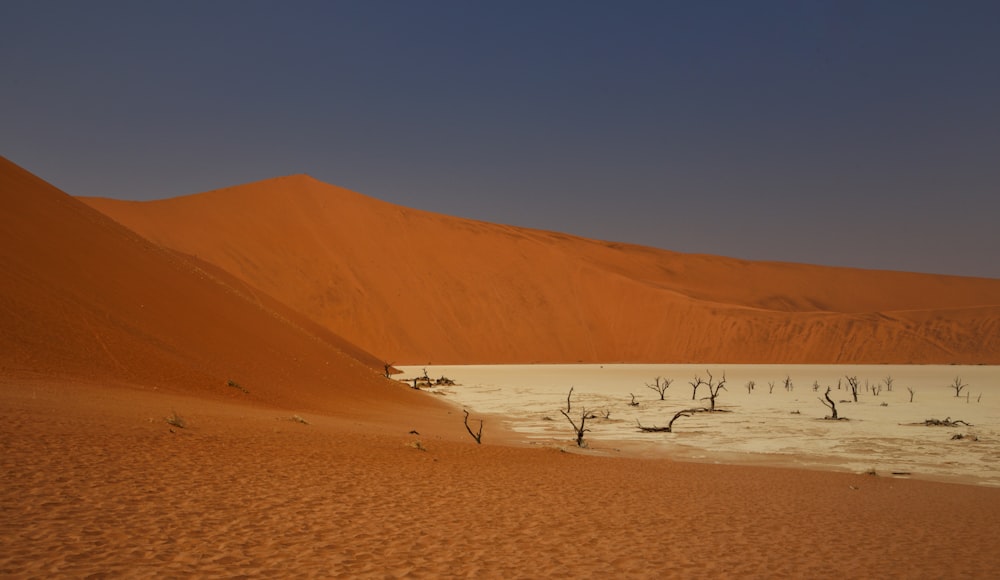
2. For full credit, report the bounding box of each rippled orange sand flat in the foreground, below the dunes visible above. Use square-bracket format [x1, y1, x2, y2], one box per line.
[0, 377, 1000, 578]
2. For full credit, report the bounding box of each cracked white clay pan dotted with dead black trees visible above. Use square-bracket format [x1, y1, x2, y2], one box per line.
[401, 364, 1000, 487]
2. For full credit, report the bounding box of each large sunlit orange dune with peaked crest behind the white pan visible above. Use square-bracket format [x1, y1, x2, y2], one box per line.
[85, 175, 1000, 364]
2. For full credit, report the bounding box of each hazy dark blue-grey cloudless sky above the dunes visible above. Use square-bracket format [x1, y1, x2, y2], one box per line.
[0, 0, 1000, 278]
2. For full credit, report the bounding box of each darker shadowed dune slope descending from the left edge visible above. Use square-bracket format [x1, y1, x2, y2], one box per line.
[0, 160, 446, 422]
